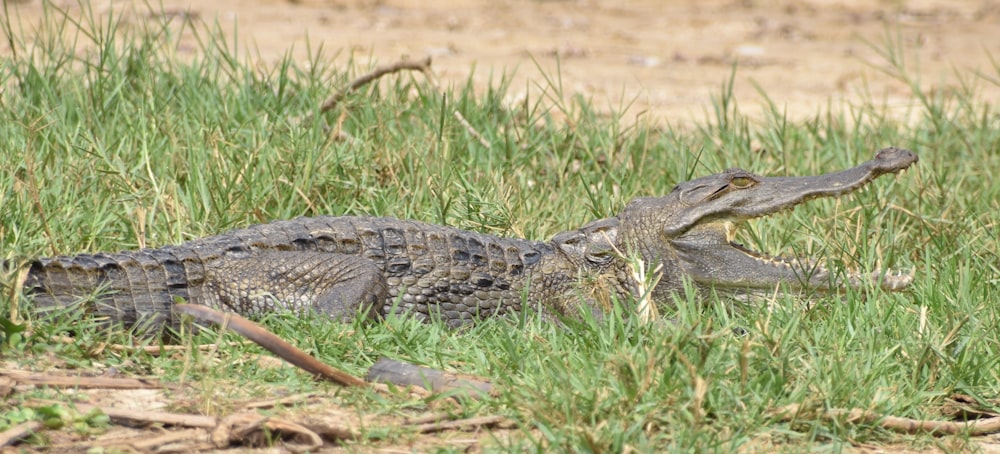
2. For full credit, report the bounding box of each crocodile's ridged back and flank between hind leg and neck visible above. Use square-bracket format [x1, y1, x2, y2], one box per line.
[220, 216, 562, 325]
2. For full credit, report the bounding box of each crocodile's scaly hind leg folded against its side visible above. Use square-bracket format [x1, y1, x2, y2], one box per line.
[202, 250, 388, 320]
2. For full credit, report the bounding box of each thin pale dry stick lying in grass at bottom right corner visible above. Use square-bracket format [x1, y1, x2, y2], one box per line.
[773, 404, 1000, 436]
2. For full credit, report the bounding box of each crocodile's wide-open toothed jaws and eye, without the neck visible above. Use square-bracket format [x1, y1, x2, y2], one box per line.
[664, 148, 917, 292]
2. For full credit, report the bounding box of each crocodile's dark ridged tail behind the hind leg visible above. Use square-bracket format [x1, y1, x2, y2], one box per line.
[23, 248, 204, 331]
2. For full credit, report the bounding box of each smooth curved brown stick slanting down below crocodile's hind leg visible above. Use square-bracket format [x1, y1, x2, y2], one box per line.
[174, 304, 368, 386]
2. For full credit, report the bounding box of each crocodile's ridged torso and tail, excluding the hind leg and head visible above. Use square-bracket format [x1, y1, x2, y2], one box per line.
[25, 217, 563, 328]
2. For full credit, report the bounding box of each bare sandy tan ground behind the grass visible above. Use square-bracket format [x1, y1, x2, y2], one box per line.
[0, 0, 1000, 125]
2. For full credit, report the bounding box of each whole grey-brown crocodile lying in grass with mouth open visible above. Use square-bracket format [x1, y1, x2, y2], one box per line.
[23, 147, 918, 329]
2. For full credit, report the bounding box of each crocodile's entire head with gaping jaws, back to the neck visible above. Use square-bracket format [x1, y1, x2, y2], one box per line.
[616, 148, 917, 293]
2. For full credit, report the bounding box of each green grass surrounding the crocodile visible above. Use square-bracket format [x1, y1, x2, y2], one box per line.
[0, 2, 1000, 452]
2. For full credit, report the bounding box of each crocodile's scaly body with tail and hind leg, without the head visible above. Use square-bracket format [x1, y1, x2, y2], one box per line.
[25, 216, 596, 326]
